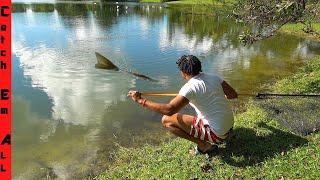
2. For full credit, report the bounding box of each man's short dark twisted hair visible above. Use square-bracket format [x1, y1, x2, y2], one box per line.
[177, 55, 202, 76]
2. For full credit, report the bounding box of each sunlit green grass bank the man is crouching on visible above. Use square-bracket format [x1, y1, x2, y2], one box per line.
[98, 57, 320, 179]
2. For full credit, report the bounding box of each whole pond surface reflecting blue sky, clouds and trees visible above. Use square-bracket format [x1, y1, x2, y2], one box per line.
[12, 2, 320, 179]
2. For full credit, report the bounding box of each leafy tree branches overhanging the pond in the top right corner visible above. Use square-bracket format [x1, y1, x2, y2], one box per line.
[233, 0, 320, 44]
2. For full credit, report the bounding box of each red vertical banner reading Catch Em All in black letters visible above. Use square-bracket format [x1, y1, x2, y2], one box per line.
[0, 0, 12, 180]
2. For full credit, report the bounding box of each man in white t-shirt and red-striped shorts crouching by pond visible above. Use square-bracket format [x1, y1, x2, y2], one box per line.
[128, 55, 238, 154]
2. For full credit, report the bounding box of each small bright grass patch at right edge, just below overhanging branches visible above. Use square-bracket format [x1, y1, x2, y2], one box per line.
[279, 23, 320, 40]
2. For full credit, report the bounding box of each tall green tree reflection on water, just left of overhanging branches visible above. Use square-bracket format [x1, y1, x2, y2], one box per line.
[134, 5, 246, 52]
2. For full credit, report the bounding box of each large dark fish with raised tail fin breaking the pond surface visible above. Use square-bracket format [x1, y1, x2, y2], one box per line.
[95, 52, 156, 81]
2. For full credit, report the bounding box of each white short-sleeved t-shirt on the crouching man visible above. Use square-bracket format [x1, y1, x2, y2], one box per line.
[179, 73, 234, 136]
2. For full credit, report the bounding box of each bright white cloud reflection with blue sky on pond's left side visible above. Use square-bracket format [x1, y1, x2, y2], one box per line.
[13, 9, 136, 125]
